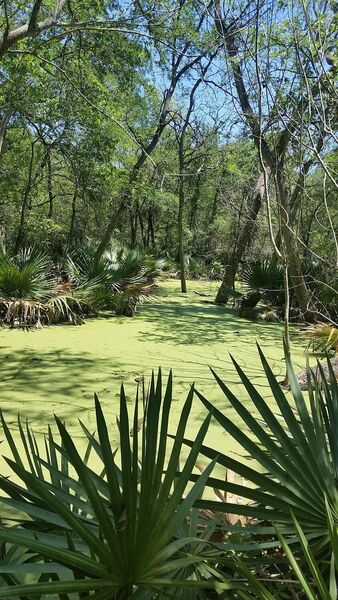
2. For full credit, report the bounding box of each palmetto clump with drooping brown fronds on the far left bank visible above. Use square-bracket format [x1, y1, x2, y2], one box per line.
[0, 248, 163, 328]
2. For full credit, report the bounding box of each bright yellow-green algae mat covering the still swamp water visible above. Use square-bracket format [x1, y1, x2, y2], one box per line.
[0, 281, 312, 474]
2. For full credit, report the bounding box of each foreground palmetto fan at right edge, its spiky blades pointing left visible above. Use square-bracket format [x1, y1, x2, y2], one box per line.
[187, 342, 338, 557]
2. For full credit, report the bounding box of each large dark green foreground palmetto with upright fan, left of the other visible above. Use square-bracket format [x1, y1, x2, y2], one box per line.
[0, 372, 232, 600]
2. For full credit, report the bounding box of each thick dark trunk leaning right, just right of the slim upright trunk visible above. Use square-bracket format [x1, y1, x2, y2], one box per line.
[215, 173, 265, 304]
